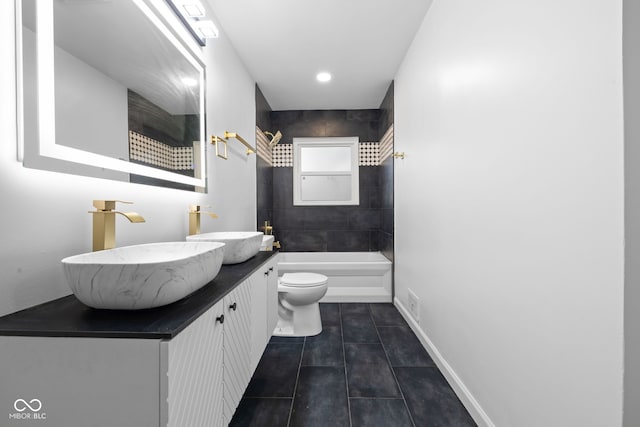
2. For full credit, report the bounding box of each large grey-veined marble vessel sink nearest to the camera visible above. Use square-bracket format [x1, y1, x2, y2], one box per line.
[62, 242, 224, 310]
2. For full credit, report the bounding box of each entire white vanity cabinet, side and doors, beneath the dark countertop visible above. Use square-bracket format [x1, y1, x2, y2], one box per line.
[0, 255, 278, 427]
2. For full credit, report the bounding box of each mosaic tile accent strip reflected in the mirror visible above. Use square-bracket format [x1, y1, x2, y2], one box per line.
[129, 130, 193, 170]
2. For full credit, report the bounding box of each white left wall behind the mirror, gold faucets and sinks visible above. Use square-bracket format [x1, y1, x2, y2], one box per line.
[0, 1, 256, 315]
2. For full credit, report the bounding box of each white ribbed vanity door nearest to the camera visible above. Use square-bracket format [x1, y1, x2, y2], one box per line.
[160, 301, 226, 427]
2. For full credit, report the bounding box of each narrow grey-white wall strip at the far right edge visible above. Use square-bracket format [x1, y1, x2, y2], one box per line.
[623, 0, 640, 427]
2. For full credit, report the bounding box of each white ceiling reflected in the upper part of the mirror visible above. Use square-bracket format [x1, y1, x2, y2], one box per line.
[51, 0, 200, 114]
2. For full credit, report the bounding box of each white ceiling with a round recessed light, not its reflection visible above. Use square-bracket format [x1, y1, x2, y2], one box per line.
[207, 0, 431, 111]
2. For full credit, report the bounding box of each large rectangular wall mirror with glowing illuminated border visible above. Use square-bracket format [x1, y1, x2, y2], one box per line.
[20, 0, 206, 191]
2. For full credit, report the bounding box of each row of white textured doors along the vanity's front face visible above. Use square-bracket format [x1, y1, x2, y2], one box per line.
[168, 255, 278, 426]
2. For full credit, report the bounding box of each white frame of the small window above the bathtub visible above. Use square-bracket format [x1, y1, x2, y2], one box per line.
[293, 137, 360, 206]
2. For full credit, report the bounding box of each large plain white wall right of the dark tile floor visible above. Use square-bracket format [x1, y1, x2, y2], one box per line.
[395, 0, 624, 427]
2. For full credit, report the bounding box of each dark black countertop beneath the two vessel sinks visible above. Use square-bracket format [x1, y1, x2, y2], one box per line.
[0, 252, 278, 339]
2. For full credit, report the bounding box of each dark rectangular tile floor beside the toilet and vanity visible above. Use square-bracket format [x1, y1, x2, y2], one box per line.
[230, 304, 476, 427]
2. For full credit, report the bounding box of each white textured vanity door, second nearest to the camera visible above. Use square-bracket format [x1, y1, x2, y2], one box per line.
[223, 280, 251, 422]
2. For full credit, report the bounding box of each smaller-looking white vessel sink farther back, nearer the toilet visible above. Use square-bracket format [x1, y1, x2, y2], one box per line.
[187, 231, 263, 264]
